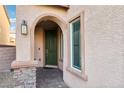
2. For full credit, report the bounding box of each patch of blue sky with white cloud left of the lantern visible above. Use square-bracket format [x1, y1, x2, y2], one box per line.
[6, 5, 16, 32]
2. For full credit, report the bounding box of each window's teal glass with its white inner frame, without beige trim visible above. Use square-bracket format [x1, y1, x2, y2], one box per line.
[70, 18, 81, 70]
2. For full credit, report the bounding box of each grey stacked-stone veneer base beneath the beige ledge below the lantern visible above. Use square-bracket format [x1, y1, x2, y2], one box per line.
[13, 67, 36, 88]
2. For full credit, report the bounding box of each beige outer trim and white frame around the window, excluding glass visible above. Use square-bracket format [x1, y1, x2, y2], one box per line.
[66, 11, 88, 81]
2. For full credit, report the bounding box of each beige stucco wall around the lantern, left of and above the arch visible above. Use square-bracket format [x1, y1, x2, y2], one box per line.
[16, 5, 67, 62]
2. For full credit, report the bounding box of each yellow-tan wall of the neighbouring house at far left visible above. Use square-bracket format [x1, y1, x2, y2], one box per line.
[0, 5, 10, 45]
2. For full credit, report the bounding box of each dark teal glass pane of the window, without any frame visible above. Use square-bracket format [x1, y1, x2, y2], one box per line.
[72, 20, 81, 70]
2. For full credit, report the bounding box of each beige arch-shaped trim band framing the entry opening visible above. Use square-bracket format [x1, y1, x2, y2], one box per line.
[30, 13, 68, 66]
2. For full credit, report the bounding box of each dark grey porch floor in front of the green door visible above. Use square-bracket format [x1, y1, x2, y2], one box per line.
[36, 68, 68, 88]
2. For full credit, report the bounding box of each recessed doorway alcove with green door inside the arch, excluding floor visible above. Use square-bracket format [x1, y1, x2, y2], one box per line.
[34, 18, 63, 70]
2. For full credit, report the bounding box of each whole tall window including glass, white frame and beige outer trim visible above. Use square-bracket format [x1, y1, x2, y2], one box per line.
[66, 11, 88, 81]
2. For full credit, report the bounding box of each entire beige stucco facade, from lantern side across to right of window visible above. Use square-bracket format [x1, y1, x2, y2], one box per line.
[16, 6, 124, 87]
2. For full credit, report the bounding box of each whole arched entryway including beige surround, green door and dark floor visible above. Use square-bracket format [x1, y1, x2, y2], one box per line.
[31, 13, 67, 87]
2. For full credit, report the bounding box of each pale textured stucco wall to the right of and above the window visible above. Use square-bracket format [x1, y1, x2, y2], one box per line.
[64, 6, 124, 87]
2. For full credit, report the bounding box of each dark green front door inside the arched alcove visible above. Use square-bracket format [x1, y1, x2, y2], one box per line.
[45, 31, 57, 66]
